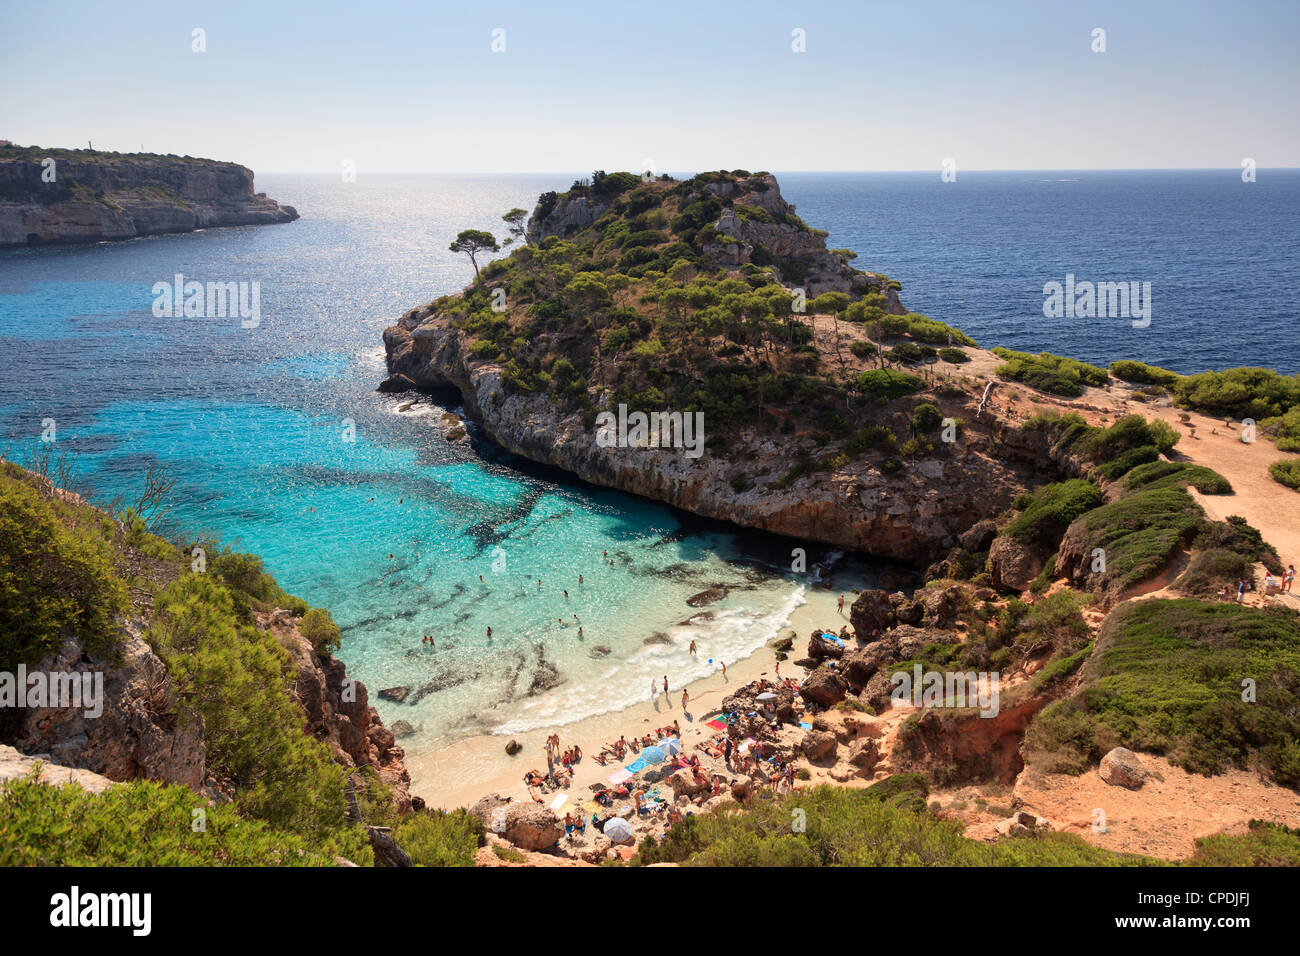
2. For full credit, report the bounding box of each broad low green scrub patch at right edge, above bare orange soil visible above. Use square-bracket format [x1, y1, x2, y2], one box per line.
[1026, 598, 1300, 788]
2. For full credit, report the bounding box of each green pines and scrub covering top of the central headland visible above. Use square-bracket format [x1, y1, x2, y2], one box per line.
[416, 170, 974, 476]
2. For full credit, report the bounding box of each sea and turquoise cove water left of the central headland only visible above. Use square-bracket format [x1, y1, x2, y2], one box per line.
[0, 177, 868, 750]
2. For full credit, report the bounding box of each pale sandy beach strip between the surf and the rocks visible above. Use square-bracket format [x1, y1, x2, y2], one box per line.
[404, 580, 862, 814]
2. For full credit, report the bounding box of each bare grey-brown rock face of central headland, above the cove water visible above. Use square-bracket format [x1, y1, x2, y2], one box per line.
[382, 311, 1041, 564]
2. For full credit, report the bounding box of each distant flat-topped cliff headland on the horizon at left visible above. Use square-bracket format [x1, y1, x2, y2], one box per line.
[0, 146, 298, 247]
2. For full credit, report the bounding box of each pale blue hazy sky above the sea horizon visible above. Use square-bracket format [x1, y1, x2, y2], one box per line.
[0, 0, 1300, 176]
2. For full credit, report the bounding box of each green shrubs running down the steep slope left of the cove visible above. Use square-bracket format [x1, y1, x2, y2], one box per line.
[0, 462, 387, 864]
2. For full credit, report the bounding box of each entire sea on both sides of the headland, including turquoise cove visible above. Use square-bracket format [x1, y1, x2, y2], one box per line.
[0, 170, 1300, 748]
